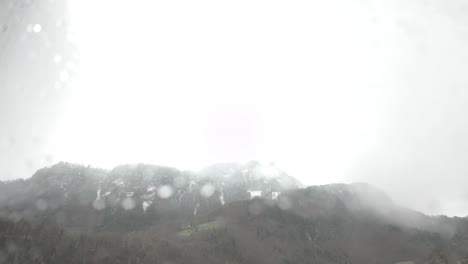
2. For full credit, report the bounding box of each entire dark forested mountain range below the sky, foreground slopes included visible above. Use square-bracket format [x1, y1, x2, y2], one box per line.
[0, 162, 468, 264]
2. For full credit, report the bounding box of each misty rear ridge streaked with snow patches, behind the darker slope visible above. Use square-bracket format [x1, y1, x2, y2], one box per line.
[0, 162, 301, 231]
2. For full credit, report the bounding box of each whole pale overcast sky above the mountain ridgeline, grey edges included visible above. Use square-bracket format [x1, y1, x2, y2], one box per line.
[0, 0, 468, 216]
